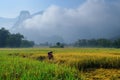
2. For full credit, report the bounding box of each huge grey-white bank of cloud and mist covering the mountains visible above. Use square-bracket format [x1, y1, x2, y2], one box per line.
[16, 0, 120, 43]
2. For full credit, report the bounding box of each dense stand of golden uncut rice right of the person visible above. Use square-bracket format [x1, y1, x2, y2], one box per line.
[55, 53, 120, 70]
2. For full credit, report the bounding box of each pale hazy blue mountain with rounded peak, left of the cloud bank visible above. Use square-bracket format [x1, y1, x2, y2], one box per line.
[0, 11, 43, 29]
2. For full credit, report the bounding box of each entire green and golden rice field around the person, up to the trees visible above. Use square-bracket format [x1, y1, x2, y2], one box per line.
[0, 48, 120, 80]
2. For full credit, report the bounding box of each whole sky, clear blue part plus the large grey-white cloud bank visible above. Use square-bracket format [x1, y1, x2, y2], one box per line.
[0, 0, 120, 43]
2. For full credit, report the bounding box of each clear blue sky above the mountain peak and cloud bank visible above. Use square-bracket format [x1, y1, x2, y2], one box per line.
[0, 0, 85, 17]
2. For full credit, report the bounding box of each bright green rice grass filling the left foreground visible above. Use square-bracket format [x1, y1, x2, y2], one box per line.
[0, 57, 80, 80]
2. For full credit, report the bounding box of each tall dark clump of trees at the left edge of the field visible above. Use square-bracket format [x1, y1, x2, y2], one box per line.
[0, 28, 34, 48]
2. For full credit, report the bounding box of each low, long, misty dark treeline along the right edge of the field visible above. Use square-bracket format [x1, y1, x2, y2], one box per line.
[74, 38, 120, 48]
